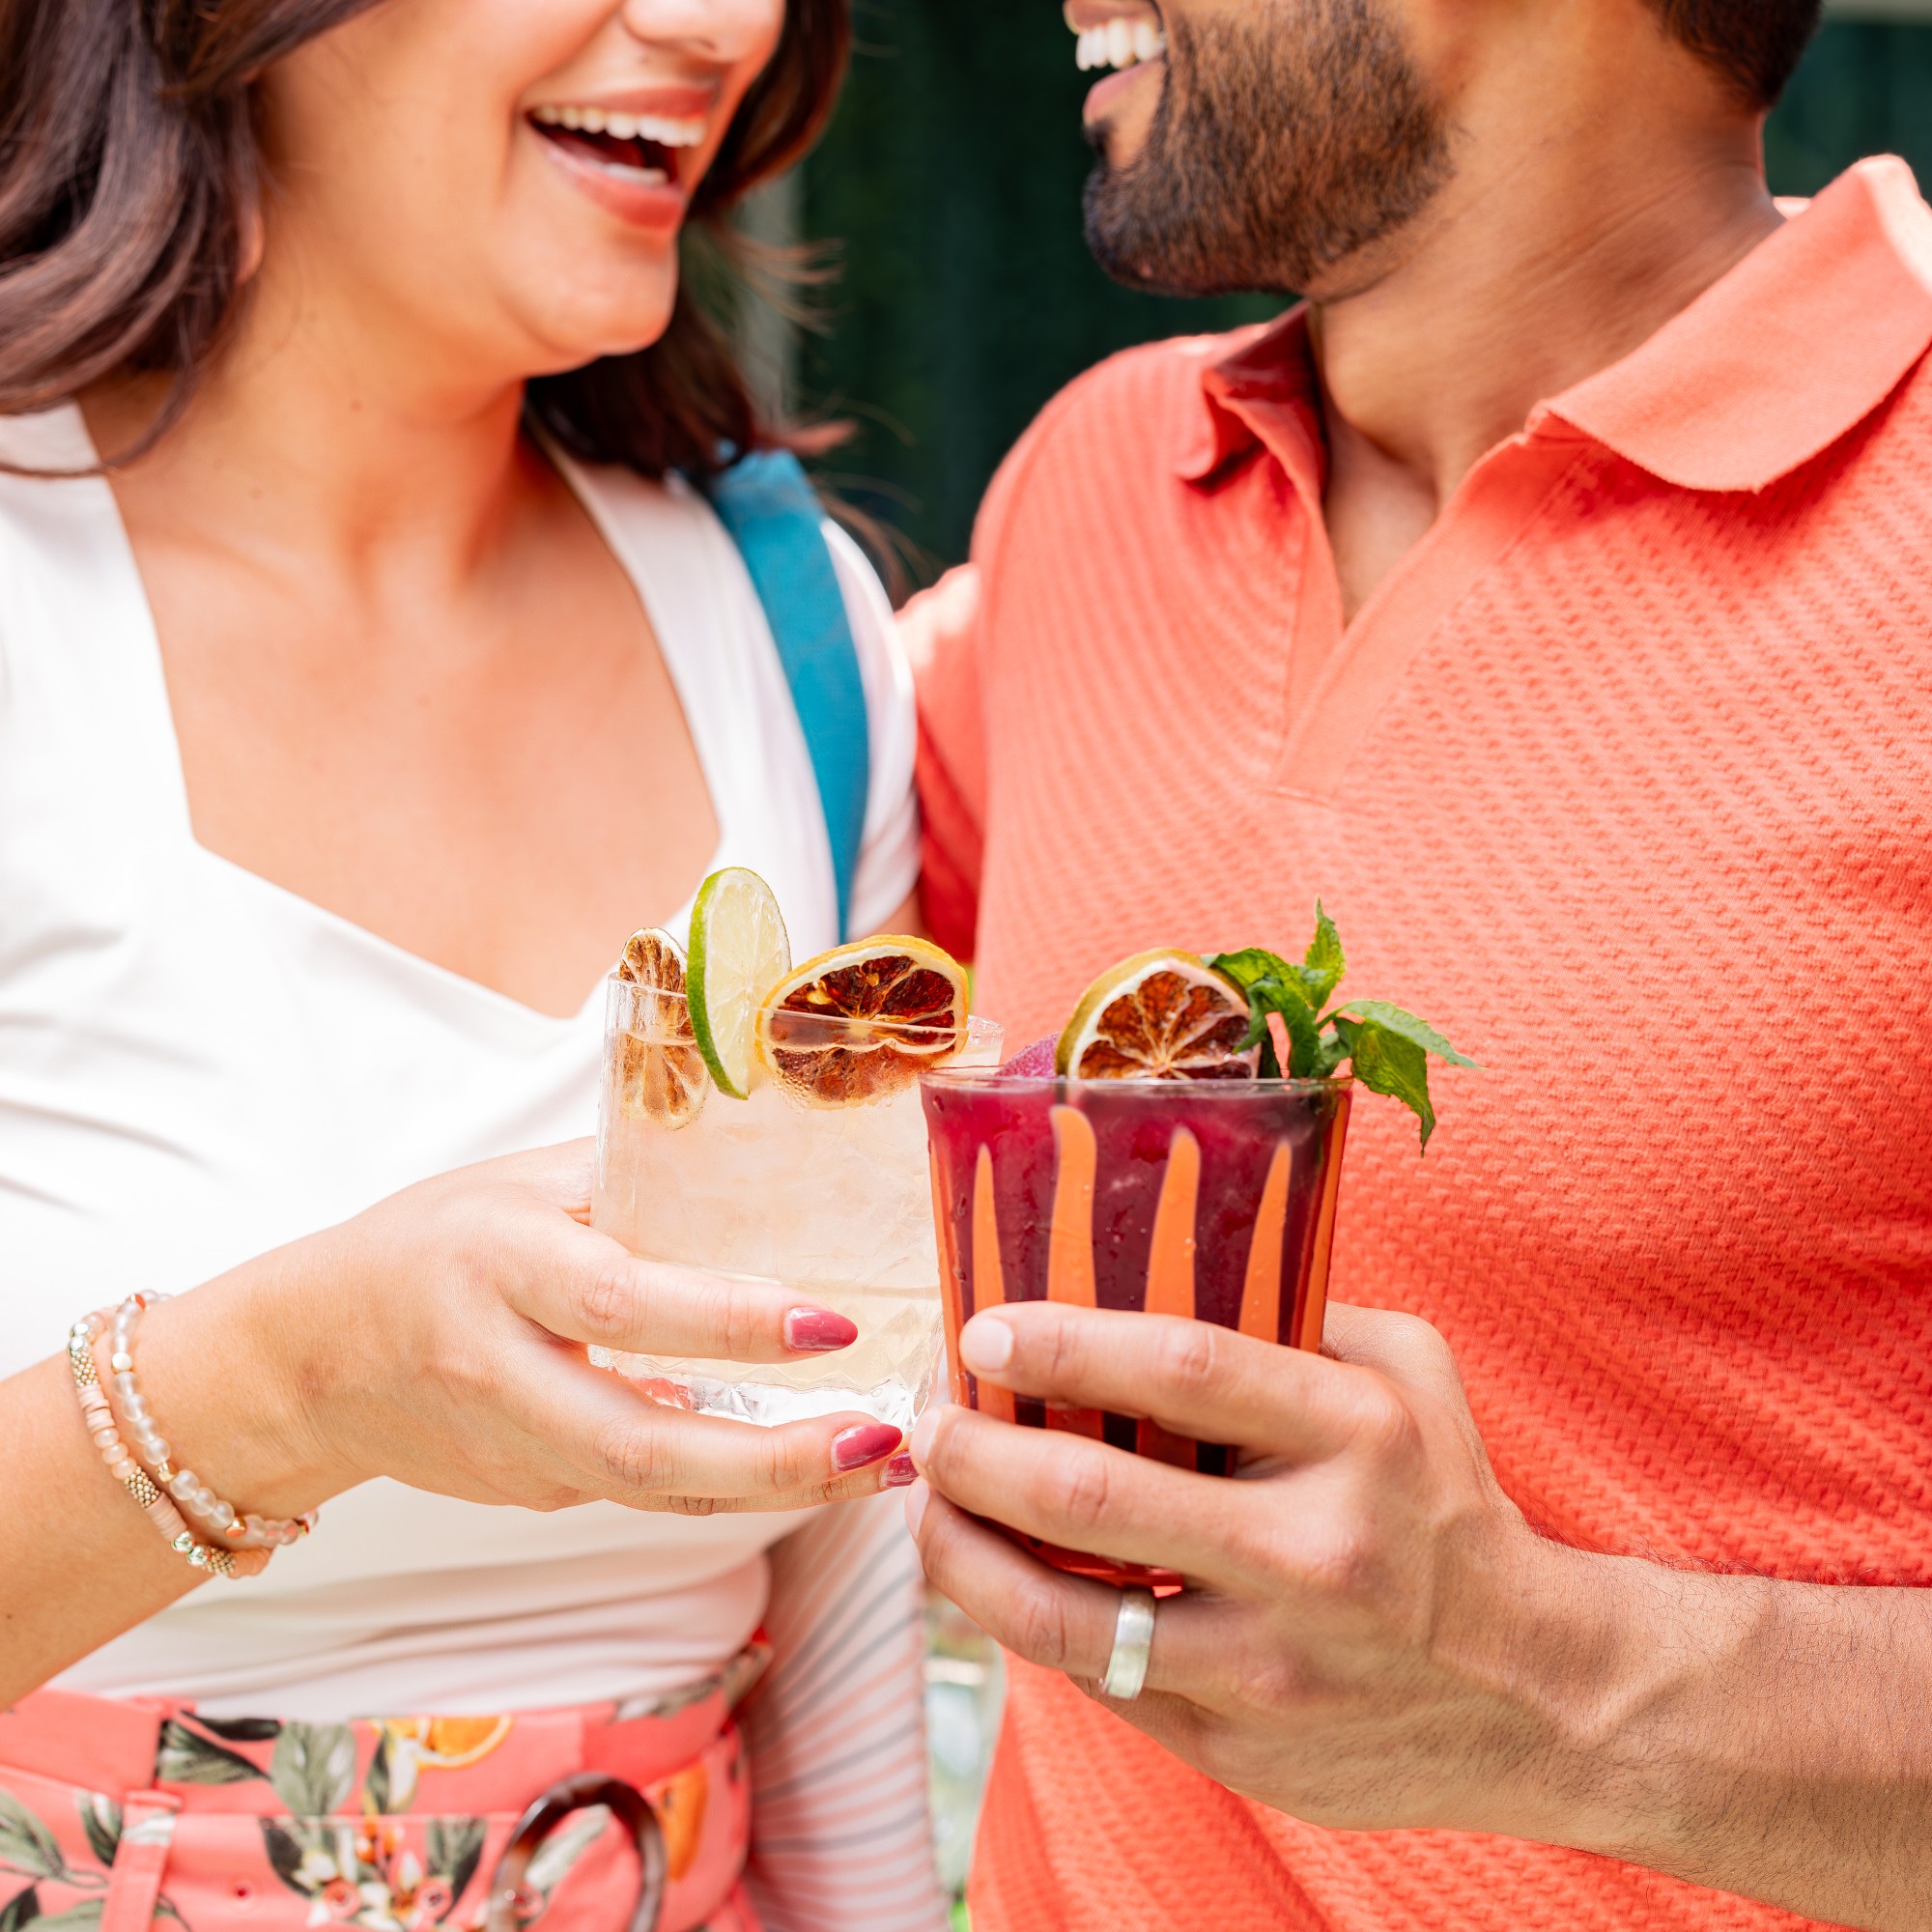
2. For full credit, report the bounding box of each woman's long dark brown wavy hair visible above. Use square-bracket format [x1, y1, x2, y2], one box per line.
[0, 0, 850, 477]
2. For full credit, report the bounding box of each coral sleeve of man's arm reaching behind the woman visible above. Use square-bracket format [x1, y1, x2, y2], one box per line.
[898, 564, 985, 960]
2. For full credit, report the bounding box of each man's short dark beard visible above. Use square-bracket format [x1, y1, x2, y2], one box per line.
[1086, 0, 1453, 296]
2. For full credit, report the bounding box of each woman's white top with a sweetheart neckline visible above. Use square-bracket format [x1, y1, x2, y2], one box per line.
[0, 408, 918, 1721]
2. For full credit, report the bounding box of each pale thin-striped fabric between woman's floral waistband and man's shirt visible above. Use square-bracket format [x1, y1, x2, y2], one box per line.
[744, 1497, 947, 1932]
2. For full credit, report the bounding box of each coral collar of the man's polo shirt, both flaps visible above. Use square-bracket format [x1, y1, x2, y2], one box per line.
[1175, 156, 1932, 497]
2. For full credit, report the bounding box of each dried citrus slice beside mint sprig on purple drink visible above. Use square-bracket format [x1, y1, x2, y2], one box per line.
[1053, 949, 1262, 1080]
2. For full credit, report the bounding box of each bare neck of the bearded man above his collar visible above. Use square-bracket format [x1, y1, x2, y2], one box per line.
[1312, 22, 1781, 618]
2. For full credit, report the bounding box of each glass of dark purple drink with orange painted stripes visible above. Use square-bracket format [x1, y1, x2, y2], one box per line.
[920, 1070, 1352, 1588]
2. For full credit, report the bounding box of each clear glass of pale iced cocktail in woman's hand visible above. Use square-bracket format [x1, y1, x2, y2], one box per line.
[591, 976, 1001, 1430]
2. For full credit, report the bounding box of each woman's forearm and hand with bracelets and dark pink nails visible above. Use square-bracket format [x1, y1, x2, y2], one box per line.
[0, 1142, 898, 1708]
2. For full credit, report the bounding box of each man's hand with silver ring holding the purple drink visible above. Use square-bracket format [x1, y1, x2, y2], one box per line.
[914, 1302, 1600, 1832]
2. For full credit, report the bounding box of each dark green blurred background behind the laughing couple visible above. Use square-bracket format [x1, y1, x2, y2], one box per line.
[798, 13, 1932, 572]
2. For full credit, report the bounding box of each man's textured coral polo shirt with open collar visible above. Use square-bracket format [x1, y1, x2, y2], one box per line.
[910, 160, 1932, 1932]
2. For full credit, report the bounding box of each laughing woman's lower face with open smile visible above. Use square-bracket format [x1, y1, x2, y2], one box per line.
[263, 0, 784, 388]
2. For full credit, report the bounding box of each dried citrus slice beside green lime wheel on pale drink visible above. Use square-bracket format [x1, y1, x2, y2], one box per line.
[757, 935, 966, 1107]
